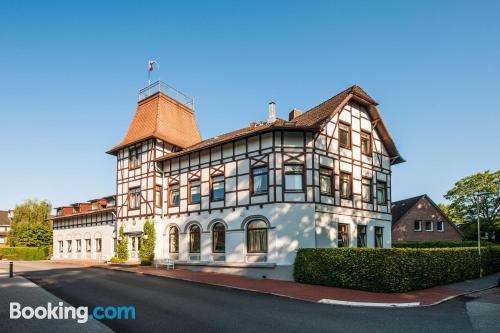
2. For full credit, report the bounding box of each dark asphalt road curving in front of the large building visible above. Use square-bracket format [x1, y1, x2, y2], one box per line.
[3, 263, 500, 333]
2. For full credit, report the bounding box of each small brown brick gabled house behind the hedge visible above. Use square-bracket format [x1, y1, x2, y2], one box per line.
[391, 194, 463, 242]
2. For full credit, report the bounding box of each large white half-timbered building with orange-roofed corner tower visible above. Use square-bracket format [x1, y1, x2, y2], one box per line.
[108, 82, 404, 279]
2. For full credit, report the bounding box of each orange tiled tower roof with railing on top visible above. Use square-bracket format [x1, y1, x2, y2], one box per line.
[107, 84, 201, 155]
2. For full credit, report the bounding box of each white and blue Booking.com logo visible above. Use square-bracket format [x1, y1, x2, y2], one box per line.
[10, 302, 135, 324]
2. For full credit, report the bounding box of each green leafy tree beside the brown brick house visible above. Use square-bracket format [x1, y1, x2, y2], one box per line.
[444, 170, 500, 240]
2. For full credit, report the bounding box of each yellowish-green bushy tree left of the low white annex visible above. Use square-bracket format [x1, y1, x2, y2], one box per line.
[7, 200, 52, 246]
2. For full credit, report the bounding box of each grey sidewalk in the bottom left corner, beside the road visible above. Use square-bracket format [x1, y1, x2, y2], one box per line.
[0, 269, 112, 333]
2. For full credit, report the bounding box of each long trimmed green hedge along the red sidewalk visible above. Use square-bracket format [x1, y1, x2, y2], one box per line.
[294, 247, 500, 292]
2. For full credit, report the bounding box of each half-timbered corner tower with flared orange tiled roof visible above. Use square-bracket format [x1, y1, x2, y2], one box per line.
[107, 81, 201, 259]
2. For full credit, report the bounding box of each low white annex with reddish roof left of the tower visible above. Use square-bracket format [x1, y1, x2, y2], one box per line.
[52, 196, 116, 261]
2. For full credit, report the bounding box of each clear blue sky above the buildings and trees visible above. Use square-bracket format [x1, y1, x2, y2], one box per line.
[0, 1, 500, 209]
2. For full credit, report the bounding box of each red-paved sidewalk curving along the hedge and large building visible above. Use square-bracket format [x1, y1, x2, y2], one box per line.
[92, 265, 500, 307]
